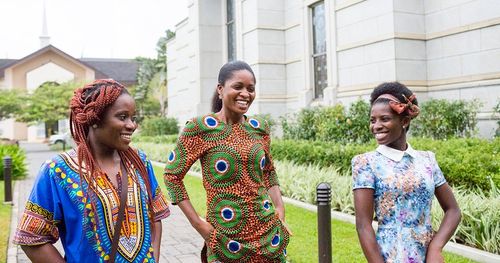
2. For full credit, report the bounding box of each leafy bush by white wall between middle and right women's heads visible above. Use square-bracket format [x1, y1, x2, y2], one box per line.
[281, 100, 371, 143]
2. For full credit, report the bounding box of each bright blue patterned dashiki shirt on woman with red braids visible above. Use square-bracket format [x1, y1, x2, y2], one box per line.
[14, 150, 170, 262]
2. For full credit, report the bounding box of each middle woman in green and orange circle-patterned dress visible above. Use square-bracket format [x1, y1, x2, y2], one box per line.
[165, 61, 289, 263]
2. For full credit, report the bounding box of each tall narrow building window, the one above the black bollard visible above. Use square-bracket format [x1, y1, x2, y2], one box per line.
[311, 1, 328, 98]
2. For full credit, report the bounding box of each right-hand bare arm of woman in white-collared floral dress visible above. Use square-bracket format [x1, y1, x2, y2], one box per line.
[426, 183, 462, 262]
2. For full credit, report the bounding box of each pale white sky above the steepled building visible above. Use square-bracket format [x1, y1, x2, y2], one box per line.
[0, 0, 188, 59]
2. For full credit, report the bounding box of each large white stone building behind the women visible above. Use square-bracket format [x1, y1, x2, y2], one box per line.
[167, 0, 500, 137]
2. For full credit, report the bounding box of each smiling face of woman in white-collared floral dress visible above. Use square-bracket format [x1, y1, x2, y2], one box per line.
[370, 102, 410, 151]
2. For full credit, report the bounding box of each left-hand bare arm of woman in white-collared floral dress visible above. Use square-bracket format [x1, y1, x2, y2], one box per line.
[354, 188, 384, 263]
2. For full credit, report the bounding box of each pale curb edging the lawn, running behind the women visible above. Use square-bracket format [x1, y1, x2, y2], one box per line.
[151, 161, 500, 263]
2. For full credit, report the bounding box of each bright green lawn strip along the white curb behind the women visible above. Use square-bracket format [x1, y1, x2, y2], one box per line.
[155, 167, 475, 263]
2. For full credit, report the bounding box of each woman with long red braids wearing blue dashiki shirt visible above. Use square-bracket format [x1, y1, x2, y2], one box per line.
[14, 80, 170, 262]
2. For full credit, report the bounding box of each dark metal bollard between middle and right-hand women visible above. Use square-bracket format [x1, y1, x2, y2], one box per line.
[316, 183, 332, 263]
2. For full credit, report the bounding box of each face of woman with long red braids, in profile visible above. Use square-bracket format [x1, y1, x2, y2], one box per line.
[89, 93, 137, 154]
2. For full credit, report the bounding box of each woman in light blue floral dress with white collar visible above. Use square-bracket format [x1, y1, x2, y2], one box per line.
[352, 82, 461, 263]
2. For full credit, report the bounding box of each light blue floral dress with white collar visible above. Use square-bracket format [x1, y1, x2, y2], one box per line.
[352, 144, 446, 263]
